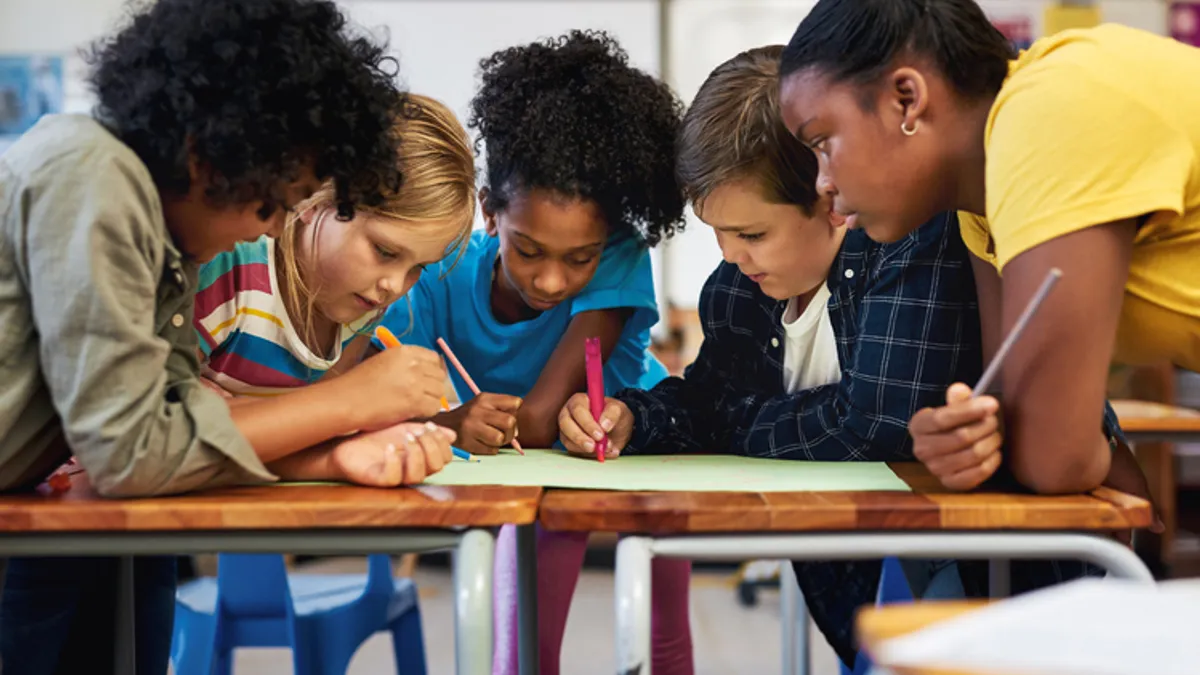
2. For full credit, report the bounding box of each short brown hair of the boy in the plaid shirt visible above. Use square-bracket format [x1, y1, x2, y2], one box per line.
[676, 44, 817, 216]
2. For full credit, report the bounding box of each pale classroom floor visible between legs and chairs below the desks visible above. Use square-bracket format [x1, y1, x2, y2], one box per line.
[204, 558, 838, 675]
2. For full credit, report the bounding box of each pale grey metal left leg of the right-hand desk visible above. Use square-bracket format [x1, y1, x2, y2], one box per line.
[616, 537, 653, 675]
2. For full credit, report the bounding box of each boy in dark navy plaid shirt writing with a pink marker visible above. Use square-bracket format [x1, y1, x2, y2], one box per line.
[559, 47, 1117, 664]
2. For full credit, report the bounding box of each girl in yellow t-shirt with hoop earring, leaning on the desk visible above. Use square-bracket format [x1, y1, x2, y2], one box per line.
[780, 0, 1200, 492]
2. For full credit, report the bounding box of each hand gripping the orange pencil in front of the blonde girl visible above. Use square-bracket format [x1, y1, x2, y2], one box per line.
[348, 345, 446, 429]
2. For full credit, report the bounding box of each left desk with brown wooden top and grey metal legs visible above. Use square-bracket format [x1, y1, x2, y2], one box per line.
[0, 477, 542, 675]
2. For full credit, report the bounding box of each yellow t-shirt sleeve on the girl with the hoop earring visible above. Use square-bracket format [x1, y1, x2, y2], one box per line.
[972, 64, 1195, 269]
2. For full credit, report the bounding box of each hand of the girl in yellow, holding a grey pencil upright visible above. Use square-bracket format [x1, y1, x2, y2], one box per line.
[908, 383, 1003, 490]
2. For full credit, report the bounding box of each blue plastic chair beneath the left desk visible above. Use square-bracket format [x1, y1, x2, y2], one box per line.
[170, 554, 425, 675]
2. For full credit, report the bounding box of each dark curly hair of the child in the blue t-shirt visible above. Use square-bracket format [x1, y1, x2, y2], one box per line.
[468, 31, 684, 246]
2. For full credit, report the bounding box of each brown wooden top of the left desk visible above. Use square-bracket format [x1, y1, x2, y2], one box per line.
[0, 476, 542, 537]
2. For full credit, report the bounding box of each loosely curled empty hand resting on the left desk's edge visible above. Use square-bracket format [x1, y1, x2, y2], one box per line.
[330, 422, 455, 488]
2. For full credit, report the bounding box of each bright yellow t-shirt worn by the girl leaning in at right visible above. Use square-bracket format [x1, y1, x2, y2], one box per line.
[960, 25, 1200, 370]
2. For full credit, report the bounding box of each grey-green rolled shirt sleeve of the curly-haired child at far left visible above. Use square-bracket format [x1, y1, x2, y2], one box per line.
[25, 153, 274, 497]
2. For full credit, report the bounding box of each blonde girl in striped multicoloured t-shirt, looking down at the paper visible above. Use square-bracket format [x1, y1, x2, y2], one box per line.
[193, 95, 475, 483]
